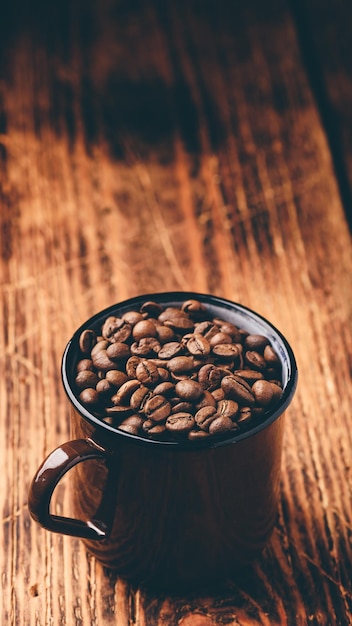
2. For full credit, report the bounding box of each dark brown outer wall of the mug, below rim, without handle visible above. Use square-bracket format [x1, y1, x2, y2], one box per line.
[71, 400, 284, 589]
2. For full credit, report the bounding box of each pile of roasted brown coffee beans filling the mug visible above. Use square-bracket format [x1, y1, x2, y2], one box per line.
[75, 300, 282, 440]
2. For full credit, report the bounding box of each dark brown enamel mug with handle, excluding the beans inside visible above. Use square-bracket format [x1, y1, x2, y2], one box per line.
[29, 292, 297, 589]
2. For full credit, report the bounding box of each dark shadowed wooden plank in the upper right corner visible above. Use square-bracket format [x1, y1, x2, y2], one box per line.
[292, 0, 352, 229]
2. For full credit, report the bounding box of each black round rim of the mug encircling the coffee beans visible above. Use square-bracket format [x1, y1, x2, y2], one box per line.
[61, 291, 298, 450]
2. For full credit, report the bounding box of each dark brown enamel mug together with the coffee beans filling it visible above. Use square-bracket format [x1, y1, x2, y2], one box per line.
[29, 292, 297, 592]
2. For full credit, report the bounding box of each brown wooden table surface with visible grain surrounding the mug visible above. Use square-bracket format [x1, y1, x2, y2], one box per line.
[0, 0, 352, 626]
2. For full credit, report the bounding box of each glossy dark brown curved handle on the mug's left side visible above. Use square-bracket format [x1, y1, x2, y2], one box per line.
[28, 439, 108, 540]
